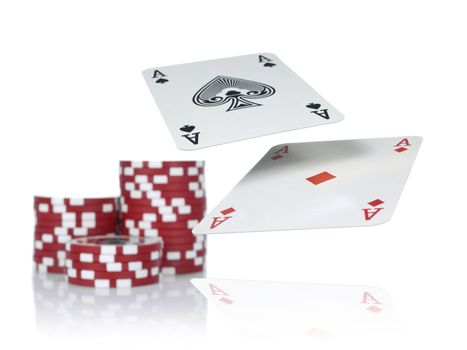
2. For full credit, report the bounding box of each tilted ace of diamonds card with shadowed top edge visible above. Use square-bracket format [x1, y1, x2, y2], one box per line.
[193, 136, 422, 234]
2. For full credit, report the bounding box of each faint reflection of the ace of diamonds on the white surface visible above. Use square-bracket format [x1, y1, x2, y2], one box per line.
[191, 278, 398, 338]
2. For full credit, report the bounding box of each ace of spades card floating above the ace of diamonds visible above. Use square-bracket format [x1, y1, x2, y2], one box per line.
[143, 53, 344, 150]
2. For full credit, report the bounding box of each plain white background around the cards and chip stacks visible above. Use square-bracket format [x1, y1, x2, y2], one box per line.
[0, 0, 467, 350]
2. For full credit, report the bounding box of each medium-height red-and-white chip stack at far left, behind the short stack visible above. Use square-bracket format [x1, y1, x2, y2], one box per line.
[34, 197, 119, 273]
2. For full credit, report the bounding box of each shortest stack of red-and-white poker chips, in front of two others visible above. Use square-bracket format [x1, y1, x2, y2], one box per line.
[66, 235, 163, 288]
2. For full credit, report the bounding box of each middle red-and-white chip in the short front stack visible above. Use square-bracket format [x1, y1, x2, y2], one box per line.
[65, 259, 162, 272]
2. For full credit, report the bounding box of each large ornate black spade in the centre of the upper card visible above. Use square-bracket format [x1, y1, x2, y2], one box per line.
[193, 75, 276, 112]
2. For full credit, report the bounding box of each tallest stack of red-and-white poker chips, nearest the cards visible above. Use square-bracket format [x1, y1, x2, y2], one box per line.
[120, 161, 206, 274]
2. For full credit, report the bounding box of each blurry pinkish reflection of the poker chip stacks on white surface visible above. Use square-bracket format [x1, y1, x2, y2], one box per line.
[33, 273, 206, 344]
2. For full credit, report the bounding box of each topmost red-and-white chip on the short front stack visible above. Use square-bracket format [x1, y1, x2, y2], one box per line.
[66, 235, 163, 256]
